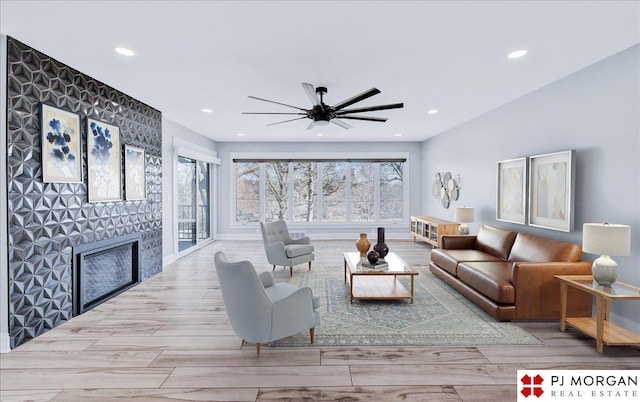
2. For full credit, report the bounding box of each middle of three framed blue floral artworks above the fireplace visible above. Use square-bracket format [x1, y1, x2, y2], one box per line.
[87, 118, 122, 202]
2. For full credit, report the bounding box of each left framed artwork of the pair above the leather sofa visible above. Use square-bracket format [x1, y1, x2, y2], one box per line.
[496, 157, 527, 225]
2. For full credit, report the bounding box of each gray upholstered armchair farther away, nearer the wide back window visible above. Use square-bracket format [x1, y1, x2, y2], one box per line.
[260, 221, 314, 276]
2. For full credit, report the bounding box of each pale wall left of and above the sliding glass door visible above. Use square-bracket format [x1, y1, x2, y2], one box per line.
[162, 117, 216, 265]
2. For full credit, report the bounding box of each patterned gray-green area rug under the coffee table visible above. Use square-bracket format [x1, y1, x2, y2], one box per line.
[270, 267, 543, 346]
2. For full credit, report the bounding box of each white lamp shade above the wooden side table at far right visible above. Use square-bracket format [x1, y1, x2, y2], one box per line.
[582, 223, 631, 255]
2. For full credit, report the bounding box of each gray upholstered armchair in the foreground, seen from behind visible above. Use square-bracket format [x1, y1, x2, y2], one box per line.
[214, 251, 320, 356]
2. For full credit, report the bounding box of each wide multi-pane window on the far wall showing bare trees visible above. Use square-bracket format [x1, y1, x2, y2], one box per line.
[232, 159, 406, 224]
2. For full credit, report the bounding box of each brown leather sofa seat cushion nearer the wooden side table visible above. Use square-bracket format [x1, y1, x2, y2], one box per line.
[458, 261, 516, 304]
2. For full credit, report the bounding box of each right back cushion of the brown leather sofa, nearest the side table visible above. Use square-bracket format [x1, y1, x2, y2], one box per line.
[509, 233, 582, 262]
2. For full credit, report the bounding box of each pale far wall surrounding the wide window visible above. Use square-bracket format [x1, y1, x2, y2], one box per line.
[217, 141, 422, 241]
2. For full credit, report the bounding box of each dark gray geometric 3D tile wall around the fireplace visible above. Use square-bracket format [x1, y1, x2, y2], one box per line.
[6, 38, 162, 347]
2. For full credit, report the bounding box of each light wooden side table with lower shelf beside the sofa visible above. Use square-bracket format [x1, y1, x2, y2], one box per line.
[555, 275, 640, 353]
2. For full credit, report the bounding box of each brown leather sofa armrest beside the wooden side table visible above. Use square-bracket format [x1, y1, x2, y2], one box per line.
[511, 261, 591, 319]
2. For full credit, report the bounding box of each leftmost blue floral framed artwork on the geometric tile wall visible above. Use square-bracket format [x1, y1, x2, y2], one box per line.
[40, 103, 82, 183]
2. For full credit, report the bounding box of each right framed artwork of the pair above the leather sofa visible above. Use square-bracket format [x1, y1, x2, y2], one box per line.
[529, 150, 575, 232]
